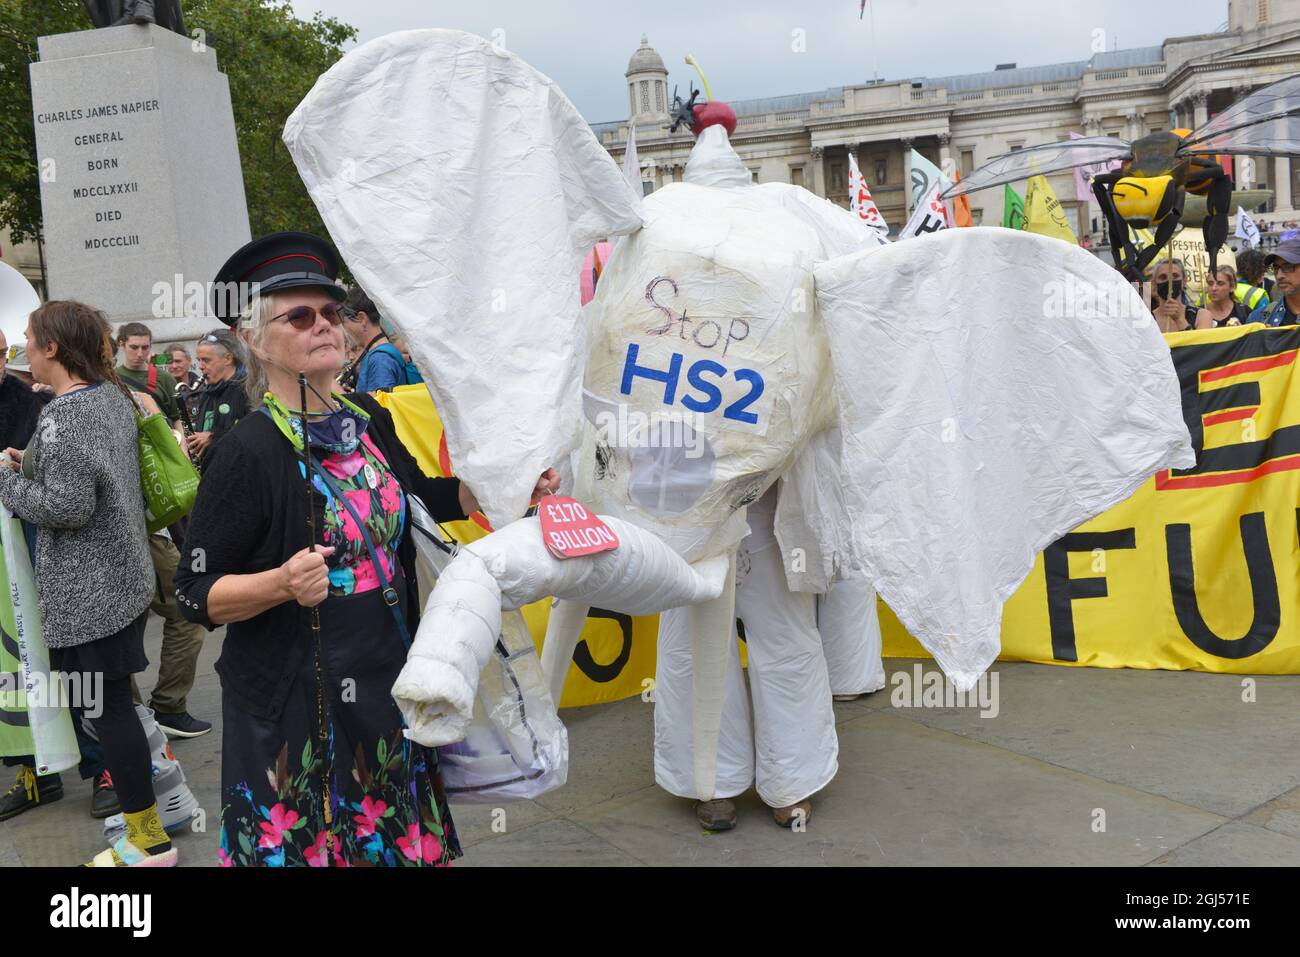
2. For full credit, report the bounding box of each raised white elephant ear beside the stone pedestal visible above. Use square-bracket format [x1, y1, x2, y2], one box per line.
[285, 30, 641, 527]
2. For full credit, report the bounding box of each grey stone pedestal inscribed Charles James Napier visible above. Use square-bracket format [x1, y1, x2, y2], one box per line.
[31, 25, 250, 345]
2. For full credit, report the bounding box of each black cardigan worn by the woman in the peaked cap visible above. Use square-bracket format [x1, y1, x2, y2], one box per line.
[176, 394, 465, 720]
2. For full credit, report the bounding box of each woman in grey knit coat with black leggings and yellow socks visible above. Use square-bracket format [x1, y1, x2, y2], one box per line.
[0, 300, 177, 867]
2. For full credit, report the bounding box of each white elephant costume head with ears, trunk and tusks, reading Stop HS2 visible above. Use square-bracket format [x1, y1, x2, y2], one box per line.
[285, 30, 1192, 797]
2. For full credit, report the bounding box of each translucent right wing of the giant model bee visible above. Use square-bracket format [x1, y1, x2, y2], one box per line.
[1178, 74, 1300, 156]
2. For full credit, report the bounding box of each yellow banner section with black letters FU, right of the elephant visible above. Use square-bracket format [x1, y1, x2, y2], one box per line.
[881, 325, 1300, 675]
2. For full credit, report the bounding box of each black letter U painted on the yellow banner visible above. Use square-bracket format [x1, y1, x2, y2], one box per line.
[1165, 512, 1282, 659]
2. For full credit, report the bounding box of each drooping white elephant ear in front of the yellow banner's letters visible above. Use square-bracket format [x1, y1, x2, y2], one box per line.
[814, 229, 1195, 689]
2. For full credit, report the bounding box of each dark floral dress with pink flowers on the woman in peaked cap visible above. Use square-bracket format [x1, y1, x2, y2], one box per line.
[217, 433, 460, 867]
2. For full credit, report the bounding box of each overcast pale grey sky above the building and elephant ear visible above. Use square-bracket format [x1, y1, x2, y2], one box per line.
[293, 0, 1227, 122]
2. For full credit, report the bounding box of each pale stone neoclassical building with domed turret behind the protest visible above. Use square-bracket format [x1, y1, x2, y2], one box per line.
[592, 0, 1300, 237]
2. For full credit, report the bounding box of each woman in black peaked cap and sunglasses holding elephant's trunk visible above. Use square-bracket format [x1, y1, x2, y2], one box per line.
[176, 234, 559, 867]
